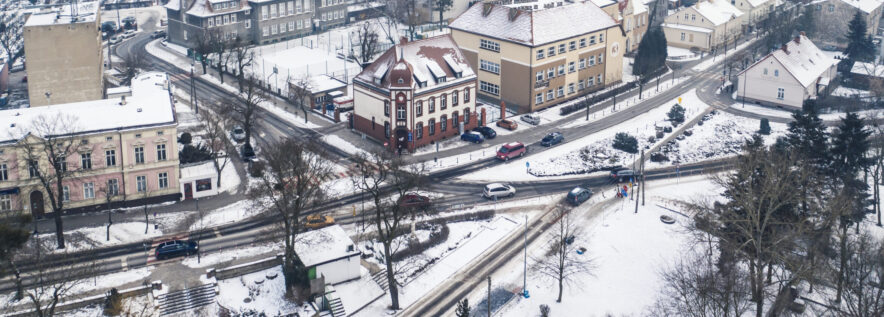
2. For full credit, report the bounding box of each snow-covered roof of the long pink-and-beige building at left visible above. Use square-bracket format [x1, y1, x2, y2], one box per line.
[0, 72, 176, 142]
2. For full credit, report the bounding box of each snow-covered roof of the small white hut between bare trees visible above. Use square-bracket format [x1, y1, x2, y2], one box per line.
[295, 225, 359, 267]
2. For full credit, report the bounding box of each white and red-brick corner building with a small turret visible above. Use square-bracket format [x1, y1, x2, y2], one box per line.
[352, 35, 478, 150]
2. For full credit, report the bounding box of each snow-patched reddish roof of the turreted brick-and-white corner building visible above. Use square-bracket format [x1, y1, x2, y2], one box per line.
[356, 34, 476, 91]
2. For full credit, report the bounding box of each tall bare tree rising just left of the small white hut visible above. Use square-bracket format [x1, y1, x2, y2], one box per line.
[250, 139, 332, 292]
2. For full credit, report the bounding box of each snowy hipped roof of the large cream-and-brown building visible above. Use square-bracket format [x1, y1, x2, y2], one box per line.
[449, 1, 617, 46]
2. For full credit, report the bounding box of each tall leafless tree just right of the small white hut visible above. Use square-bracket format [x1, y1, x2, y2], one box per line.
[353, 150, 426, 309]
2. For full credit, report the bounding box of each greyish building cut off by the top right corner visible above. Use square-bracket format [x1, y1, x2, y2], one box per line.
[810, 0, 884, 49]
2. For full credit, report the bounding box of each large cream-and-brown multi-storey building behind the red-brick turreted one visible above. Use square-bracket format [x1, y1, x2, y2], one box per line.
[449, 1, 625, 113]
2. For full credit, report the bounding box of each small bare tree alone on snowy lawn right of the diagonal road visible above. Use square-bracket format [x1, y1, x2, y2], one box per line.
[535, 202, 593, 303]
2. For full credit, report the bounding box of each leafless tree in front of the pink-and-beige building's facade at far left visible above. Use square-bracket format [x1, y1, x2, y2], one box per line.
[13, 114, 82, 249]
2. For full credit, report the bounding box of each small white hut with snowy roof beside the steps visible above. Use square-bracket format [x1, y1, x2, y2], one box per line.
[295, 225, 362, 284]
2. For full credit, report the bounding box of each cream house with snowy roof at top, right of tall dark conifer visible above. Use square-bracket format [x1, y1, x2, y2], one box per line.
[662, 0, 745, 51]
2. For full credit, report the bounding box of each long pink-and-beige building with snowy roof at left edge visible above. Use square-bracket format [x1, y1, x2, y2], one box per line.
[0, 73, 180, 217]
